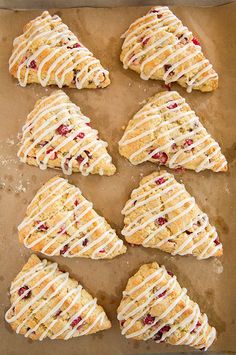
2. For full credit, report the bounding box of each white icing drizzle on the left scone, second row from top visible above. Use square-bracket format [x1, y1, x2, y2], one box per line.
[18, 91, 111, 176]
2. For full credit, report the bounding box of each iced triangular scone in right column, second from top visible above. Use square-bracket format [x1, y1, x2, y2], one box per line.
[119, 91, 227, 172]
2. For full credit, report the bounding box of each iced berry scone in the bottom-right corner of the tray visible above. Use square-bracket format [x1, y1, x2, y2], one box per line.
[118, 262, 216, 350]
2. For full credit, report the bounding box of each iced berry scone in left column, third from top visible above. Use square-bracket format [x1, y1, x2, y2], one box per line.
[18, 177, 126, 259]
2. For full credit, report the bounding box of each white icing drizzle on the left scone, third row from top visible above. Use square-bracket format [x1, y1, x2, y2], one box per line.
[18, 178, 123, 259]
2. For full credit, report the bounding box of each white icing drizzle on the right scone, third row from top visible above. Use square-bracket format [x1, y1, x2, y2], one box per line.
[121, 173, 222, 260]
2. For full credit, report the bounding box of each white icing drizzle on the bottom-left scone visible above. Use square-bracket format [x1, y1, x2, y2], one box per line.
[5, 260, 106, 340]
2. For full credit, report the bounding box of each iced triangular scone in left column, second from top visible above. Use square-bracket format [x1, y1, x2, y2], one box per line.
[18, 90, 116, 175]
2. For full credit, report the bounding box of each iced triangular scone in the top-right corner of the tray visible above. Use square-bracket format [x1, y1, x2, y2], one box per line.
[120, 6, 218, 92]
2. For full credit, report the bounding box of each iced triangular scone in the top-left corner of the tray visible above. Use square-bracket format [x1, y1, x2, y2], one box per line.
[9, 11, 110, 89]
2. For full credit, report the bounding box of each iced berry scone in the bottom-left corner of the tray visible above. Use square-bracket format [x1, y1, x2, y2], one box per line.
[5, 255, 111, 340]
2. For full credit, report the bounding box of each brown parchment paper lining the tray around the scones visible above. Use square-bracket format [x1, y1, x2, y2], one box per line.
[0, 4, 236, 355]
